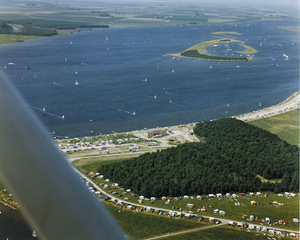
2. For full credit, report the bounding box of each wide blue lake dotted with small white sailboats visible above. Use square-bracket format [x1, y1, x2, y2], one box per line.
[0, 21, 299, 137]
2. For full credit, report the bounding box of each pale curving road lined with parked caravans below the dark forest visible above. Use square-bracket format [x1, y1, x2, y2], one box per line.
[74, 168, 300, 234]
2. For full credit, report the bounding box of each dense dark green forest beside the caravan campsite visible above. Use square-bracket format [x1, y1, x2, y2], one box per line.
[99, 118, 299, 197]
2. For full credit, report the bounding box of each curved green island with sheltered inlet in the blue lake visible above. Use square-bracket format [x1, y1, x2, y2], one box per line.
[168, 32, 257, 61]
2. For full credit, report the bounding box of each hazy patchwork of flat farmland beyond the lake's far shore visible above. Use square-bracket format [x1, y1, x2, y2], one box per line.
[0, 1, 294, 44]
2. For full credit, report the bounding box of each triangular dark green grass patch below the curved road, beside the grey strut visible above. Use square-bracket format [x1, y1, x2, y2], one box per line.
[103, 203, 209, 240]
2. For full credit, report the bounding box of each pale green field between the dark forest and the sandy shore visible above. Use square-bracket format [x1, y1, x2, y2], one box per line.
[249, 109, 299, 146]
